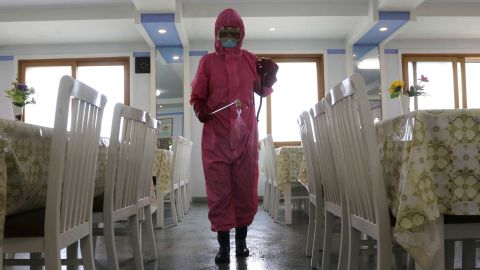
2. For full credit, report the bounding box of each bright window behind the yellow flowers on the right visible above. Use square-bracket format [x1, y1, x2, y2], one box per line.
[402, 55, 480, 110]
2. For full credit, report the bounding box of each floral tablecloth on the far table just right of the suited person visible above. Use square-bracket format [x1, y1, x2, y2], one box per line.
[275, 146, 307, 191]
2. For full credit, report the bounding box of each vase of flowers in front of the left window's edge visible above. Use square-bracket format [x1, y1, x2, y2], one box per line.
[5, 80, 35, 121]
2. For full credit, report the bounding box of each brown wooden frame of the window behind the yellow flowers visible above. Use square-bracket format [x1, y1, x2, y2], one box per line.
[402, 54, 480, 109]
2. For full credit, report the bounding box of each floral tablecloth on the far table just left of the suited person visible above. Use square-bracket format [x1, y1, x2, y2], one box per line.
[153, 149, 173, 195]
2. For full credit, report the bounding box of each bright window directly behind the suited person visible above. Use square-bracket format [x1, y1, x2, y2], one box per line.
[255, 55, 324, 146]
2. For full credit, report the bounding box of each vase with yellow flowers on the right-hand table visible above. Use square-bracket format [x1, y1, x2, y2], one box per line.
[388, 75, 428, 114]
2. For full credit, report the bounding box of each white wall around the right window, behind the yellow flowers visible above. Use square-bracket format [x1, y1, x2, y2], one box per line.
[382, 39, 480, 119]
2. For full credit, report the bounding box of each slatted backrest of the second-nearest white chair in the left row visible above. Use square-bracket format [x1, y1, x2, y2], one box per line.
[103, 103, 149, 213]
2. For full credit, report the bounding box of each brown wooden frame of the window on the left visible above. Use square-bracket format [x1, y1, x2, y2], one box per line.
[18, 57, 130, 105]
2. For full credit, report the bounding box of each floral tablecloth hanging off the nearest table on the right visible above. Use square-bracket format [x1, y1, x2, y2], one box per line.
[376, 109, 480, 269]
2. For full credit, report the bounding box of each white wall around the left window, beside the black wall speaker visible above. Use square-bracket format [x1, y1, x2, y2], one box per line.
[0, 42, 151, 114]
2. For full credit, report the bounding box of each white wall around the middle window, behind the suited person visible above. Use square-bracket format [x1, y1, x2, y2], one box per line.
[185, 40, 347, 197]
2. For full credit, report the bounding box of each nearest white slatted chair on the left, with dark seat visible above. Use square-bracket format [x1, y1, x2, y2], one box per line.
[3, 76, 107, 269]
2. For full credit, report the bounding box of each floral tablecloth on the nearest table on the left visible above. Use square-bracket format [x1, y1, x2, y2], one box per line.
[0, 119, 108, 253]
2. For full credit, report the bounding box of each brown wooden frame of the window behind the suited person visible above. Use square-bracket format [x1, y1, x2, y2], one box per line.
[257, 54, 325, 147]
